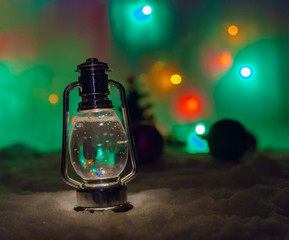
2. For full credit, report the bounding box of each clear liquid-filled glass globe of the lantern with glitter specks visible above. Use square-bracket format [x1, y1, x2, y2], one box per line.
[69, 108, 128, 184]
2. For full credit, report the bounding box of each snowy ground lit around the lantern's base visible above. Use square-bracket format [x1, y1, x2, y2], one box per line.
[0, 146, 289, 240]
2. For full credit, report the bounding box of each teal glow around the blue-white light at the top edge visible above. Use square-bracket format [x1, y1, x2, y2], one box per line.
[108, 0, 176, 53]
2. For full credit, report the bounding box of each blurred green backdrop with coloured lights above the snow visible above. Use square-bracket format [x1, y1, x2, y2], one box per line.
[0, 0, 289, 153]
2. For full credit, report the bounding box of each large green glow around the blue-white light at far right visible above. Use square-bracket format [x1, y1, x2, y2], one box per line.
[214, 39, 289, 148]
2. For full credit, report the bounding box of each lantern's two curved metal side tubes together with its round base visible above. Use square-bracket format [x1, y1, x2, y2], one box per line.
[61, 62, 138, 212]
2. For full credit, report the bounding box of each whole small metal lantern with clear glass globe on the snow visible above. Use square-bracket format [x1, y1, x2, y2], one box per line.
[61, 58, 137, 211]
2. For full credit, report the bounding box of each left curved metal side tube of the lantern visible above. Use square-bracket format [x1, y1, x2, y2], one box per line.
[61, 82, 81, 188]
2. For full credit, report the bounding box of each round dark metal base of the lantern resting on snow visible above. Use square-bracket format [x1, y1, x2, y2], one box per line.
[74, 183, 133, 212]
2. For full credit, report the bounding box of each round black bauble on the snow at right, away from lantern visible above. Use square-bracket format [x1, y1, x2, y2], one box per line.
[207, 119, 253, 162]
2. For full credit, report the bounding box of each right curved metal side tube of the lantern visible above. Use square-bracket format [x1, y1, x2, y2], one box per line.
[108, 79, 138, 183]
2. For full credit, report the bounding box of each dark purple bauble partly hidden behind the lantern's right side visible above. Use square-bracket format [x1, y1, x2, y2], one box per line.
[132, 124, 164, 165]
